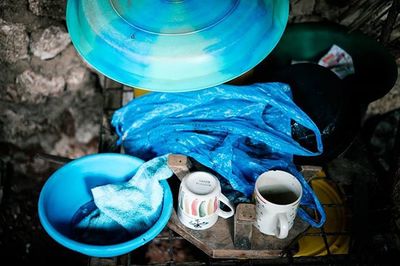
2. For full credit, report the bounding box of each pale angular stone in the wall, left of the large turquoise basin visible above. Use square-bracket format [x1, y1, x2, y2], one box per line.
[30, 26, 71, 60]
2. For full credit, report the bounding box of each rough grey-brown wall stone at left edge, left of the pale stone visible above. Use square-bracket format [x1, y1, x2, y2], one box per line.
[0, 18, 29, 63]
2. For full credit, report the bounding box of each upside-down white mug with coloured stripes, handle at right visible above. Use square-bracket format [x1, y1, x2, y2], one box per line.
[178, 171, 234, 230]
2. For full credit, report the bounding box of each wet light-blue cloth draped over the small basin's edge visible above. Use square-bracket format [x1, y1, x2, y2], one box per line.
[75, 154, 172, 243]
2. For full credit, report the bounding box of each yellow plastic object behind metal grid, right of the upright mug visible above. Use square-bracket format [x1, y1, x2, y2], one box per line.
[295, 178, 350, 257]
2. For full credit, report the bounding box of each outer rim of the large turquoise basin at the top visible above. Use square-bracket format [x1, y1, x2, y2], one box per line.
[66, 0, 290, 93]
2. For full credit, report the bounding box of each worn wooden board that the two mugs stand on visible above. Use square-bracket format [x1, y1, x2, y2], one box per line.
[168, 154, 310, 259]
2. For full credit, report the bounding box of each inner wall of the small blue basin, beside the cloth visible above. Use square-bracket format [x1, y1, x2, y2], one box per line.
[41, 155, 142, 237]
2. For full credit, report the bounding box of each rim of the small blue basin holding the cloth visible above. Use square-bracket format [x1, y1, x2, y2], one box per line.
[38, 153, 173, 257]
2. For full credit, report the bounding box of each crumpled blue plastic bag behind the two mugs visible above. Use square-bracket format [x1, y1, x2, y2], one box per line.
[112, 83, 325, 227]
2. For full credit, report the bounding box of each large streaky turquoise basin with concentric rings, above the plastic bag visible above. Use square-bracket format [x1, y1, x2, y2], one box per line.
[66, 0, 289, 92]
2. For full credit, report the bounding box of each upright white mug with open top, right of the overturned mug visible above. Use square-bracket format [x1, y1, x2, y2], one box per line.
[254, 170, 303, 239]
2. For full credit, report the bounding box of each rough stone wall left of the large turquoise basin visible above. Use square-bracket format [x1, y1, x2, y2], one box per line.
[0, 0, 102, 187]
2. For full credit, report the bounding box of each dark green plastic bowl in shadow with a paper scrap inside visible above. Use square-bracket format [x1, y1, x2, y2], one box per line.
[255, 22, 398, 104]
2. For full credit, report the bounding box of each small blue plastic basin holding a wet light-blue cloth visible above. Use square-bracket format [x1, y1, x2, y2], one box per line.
[38, 153, 173, 257]
